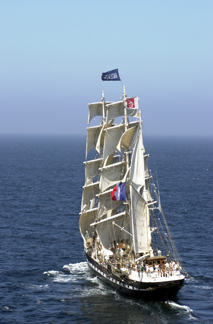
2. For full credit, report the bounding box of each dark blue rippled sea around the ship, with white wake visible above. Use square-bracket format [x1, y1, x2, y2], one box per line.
[0, 135, 213, 324]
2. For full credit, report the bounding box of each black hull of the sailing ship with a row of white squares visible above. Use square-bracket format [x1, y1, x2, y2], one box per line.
[86, 254, 184, 301]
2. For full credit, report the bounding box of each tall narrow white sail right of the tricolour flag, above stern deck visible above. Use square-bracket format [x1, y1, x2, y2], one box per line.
[130, 185, 151, 254]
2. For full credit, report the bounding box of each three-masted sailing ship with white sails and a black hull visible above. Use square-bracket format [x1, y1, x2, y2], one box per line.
[79, 86, 185, 300]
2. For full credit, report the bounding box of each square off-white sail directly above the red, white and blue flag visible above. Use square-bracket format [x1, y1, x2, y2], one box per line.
[100, 162, 125, 192]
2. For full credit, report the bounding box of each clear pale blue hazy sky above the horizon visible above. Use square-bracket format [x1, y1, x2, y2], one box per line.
[0, 0, 213, 137]
